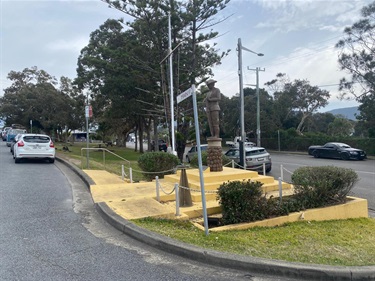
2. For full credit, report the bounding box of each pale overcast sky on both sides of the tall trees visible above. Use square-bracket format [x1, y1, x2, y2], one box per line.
[0, 0, 372, 111]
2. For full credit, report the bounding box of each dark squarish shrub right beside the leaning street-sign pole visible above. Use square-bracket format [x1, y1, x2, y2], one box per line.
[218, 180, 269, 224]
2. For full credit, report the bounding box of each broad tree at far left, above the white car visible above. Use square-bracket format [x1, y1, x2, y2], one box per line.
[0, 67, 76, 134]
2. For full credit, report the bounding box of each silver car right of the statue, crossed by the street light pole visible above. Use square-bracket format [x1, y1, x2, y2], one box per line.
[225, 146, 272, 173]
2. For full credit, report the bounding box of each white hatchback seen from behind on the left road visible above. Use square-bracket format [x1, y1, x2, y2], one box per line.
[13, 134, 55, 163]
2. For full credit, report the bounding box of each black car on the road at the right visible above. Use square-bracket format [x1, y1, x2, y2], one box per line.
[308, 142, 367, 160]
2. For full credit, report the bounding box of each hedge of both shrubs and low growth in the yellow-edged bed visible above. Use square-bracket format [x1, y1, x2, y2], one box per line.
[217, 166, 358, 225]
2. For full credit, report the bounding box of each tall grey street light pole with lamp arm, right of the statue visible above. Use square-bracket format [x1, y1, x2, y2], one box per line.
[237, 38, 264, 170]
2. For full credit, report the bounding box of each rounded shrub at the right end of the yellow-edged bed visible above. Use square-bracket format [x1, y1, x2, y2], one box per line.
[292, 166, 358, 209]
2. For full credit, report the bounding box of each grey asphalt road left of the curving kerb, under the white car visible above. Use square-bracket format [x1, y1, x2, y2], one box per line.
[0, 142, 300, 281]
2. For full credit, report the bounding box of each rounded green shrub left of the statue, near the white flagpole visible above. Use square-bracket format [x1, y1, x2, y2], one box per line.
[138, 152, 180, 180]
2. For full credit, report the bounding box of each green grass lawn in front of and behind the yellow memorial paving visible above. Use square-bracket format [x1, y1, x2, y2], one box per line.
[56, 143, 375, 266]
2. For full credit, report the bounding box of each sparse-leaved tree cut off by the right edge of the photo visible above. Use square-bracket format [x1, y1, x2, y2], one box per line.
[336, 2, 375, 137]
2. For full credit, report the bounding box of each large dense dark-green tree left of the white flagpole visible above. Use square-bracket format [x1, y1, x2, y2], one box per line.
[75, 20, 156, 152]
